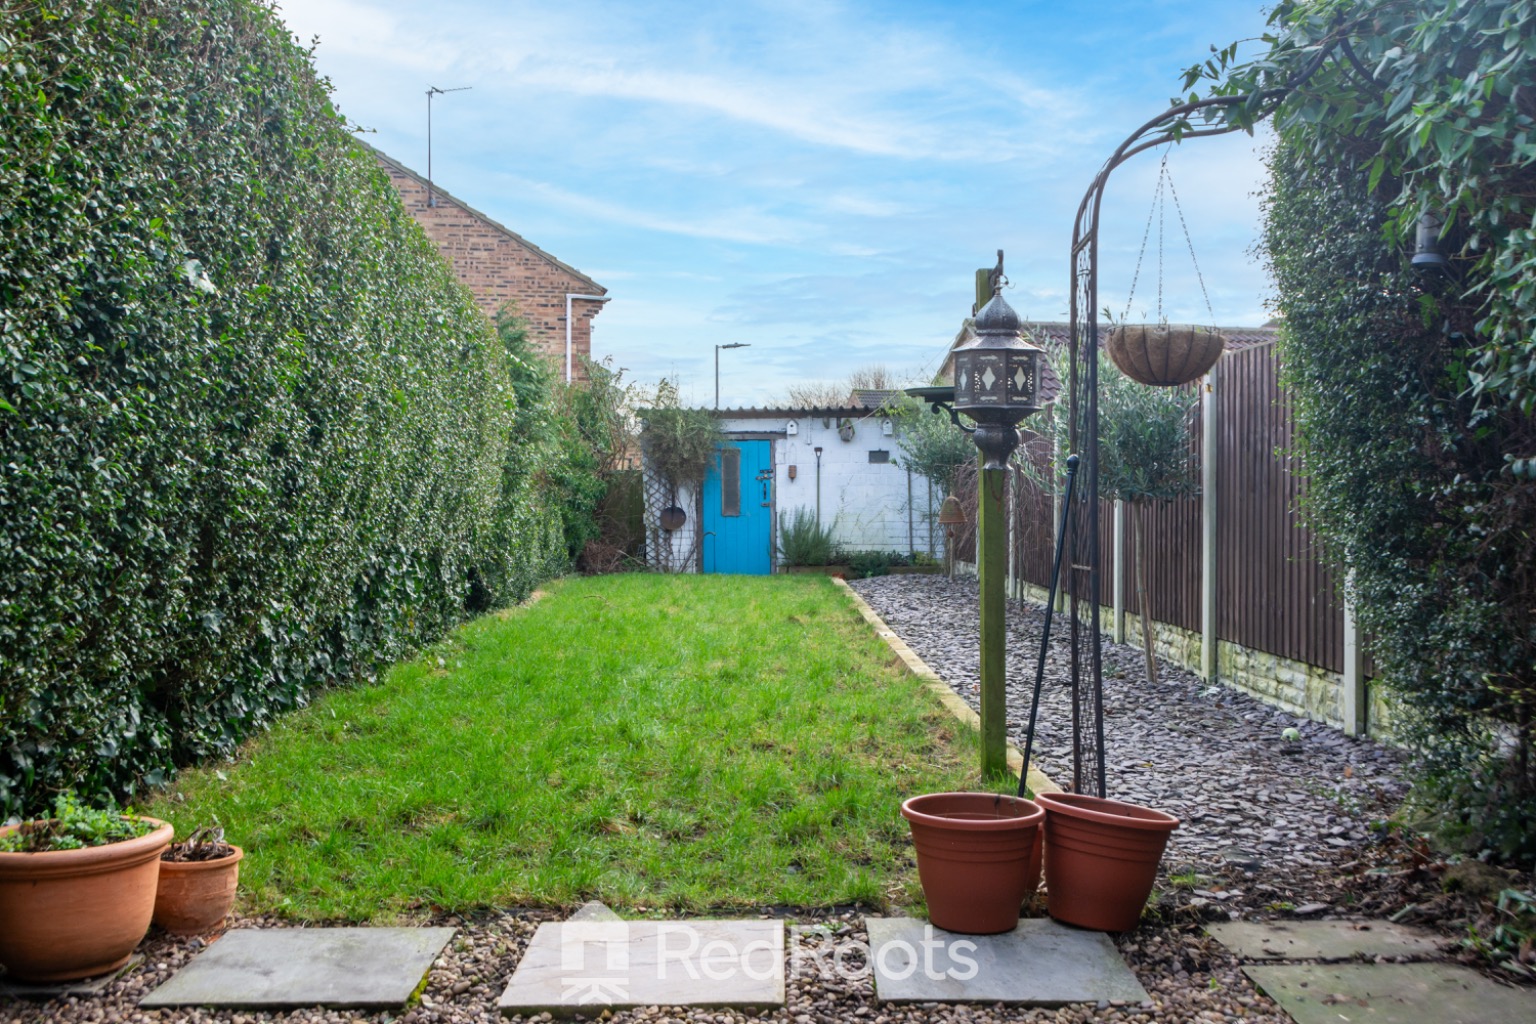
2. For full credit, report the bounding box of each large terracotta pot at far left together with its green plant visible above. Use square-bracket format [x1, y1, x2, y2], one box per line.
[0, 792, 172, 983]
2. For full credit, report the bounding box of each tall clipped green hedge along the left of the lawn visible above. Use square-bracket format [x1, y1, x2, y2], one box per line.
[0, 0, 564, 818]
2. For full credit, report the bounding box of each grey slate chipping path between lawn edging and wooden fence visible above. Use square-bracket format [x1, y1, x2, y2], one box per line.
[852, 576, 1407, 910]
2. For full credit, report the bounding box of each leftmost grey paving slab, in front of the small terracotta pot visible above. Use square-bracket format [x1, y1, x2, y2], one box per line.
[138, 927, 453, 1010]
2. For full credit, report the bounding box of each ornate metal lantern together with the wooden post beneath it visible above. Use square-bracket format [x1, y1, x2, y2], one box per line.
[908, 252, 1044, 777]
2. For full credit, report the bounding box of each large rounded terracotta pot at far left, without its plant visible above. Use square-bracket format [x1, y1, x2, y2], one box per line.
[0, 818, 172, 981]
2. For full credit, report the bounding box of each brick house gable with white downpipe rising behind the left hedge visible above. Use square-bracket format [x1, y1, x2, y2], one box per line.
[370, 147, 608, 381]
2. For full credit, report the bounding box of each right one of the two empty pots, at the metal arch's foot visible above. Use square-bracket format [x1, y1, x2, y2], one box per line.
[1035, 792, 1178, 932]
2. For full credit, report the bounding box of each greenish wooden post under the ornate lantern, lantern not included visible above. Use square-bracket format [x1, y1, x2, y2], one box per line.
[975, 470, 1008, 778]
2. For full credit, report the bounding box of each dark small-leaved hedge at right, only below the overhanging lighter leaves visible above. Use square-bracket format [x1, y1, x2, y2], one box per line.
[1266, 128, 1536, 861]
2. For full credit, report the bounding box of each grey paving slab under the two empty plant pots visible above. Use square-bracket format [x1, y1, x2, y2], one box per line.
[865, 918, 1147, 1006]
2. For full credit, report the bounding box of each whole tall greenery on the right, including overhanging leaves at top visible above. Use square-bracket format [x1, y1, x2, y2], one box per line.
[1186, 0, 1536, 864]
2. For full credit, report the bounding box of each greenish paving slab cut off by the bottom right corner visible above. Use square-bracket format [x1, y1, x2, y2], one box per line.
[1243, 964, 1536, 1024]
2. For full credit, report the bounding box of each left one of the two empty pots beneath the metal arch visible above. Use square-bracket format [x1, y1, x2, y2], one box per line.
[902, 792, 1044, 935]
